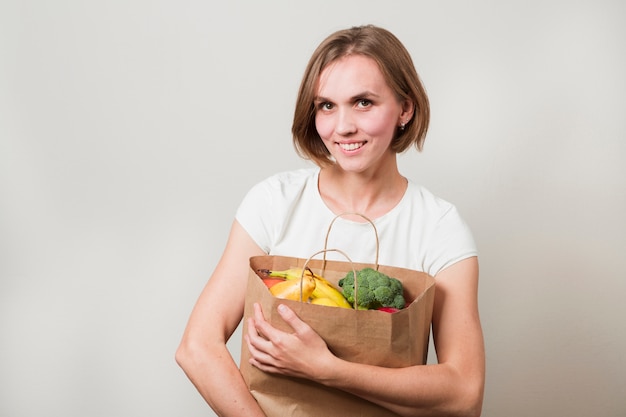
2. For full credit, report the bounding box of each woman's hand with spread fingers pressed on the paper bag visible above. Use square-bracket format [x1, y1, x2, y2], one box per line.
[246, 304, 335, 380]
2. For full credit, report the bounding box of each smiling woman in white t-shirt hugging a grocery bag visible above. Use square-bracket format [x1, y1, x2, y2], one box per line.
[176, 26, 485, 416]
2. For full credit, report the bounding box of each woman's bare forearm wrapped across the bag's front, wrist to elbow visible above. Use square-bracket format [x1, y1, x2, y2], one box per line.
[320, 359, 483, 416]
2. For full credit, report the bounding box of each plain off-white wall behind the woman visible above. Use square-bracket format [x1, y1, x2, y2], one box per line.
[0, 0, 626, 417]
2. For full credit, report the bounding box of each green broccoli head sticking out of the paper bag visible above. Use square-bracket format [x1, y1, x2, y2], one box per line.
[338, 268, 405, 310]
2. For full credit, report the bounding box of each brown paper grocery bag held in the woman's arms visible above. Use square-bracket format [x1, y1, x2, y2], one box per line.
[240, 256, 435, 417]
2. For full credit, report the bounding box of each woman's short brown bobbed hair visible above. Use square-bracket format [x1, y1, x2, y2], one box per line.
[291, 25, 430, 166]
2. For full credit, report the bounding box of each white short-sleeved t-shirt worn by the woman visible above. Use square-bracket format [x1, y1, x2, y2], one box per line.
[236, 168, 477, 276]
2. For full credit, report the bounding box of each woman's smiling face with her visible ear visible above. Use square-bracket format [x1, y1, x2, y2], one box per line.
[315, 55, 412, 172]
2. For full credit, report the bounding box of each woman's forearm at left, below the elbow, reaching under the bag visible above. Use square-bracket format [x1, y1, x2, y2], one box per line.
[176, 343, 265, 417]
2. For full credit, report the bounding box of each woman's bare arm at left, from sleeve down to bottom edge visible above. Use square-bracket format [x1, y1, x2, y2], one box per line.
[176, 221, 265, 417]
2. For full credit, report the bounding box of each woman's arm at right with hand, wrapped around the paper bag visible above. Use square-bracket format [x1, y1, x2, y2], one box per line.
[246, 258, 485, 416]
